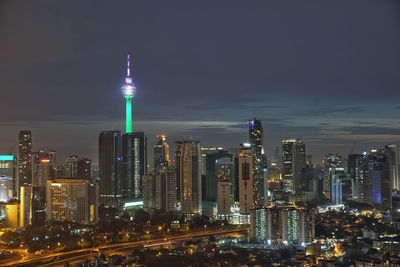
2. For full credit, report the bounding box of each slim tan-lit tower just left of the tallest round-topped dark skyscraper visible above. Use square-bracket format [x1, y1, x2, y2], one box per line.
[238, 148, 254, 214]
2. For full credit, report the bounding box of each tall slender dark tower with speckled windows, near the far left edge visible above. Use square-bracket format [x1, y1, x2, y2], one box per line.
[18, 130, 32, 185]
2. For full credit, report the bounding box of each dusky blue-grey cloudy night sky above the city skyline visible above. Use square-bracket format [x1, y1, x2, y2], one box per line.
[0, 0, 400, 164]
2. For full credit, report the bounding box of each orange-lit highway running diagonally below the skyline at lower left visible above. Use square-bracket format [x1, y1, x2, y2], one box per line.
[0, 228, 247, 267]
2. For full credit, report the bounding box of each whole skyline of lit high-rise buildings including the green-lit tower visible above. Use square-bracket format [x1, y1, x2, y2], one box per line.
[0, 55, 399, 251]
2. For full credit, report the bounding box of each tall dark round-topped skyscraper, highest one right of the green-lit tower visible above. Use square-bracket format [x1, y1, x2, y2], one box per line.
[248, 119, 267, 208]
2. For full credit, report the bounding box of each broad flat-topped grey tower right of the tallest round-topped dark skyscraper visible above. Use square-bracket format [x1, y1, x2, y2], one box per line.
[282, 139, 306, 193]
